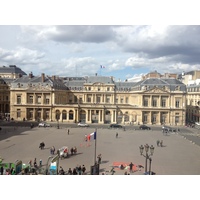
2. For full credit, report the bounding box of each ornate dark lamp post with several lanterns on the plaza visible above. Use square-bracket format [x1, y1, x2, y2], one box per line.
[139, 144, 154, 175]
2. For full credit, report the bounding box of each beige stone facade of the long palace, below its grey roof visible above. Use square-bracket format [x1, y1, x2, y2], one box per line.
[10, 83, 186, 125]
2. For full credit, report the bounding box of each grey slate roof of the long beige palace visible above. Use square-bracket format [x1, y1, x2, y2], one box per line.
[9, 76, 186, 92]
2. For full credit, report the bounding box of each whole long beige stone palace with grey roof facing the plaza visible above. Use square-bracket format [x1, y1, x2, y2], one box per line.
[10, 73, 187, 125]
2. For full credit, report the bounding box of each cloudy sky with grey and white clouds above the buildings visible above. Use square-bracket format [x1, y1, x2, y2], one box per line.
[0, 1, 200, 81]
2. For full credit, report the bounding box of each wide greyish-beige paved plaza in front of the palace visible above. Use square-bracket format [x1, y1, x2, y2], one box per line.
[0, 124, 200, 175]
